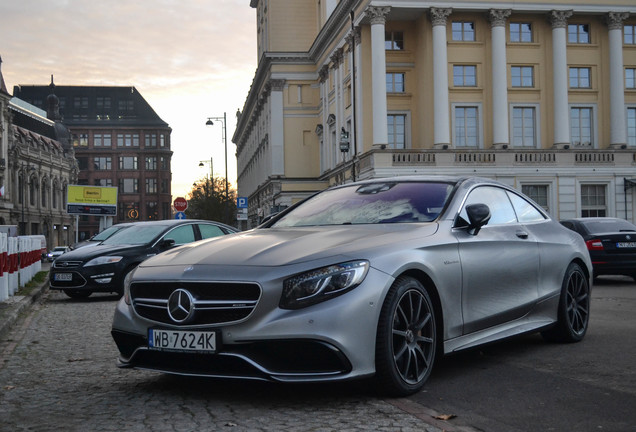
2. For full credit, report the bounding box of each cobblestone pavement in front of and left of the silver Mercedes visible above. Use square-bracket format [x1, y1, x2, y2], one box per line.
[0, 292, 462, 432]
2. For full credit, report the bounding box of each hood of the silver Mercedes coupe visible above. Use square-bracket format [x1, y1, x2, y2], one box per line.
[142, 223, 438, 267]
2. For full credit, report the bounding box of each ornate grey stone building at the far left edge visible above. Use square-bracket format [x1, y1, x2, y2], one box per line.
[0, 60, 78, 248]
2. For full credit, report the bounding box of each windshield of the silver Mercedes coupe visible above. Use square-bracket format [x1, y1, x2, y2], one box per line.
[272, 182, 453, 227]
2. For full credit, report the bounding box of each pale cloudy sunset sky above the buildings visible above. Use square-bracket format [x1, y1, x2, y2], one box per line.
[0, 0, 257, 197]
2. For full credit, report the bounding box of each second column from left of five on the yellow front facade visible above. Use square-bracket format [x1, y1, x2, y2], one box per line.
[429, 8, 453, 148]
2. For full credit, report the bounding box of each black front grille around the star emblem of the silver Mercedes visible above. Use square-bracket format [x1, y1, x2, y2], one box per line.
[130, 282, 261, 326]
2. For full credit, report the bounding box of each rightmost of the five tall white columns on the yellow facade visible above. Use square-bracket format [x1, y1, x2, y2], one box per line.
[606, 12, 629, 148]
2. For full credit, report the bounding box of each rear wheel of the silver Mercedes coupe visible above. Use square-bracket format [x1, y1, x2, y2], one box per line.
[541, 263, 590, 343]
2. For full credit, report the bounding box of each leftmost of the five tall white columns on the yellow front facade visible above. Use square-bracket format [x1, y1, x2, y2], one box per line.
[366, 6, 391, 146]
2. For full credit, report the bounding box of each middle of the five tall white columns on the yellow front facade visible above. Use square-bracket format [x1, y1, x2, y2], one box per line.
[488, 9, 512, 148]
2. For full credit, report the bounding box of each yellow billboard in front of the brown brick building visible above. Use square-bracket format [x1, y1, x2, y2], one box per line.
[66, 185, 117, 215]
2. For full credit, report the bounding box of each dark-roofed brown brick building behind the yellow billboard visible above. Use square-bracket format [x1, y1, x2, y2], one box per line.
[13, 78, 172, 240]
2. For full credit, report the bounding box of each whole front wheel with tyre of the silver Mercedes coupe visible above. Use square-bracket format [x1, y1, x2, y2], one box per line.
[376, 277, 437, 396]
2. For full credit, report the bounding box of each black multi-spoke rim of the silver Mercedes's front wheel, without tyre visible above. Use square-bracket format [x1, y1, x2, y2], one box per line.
[392, 290, 435, 384]
